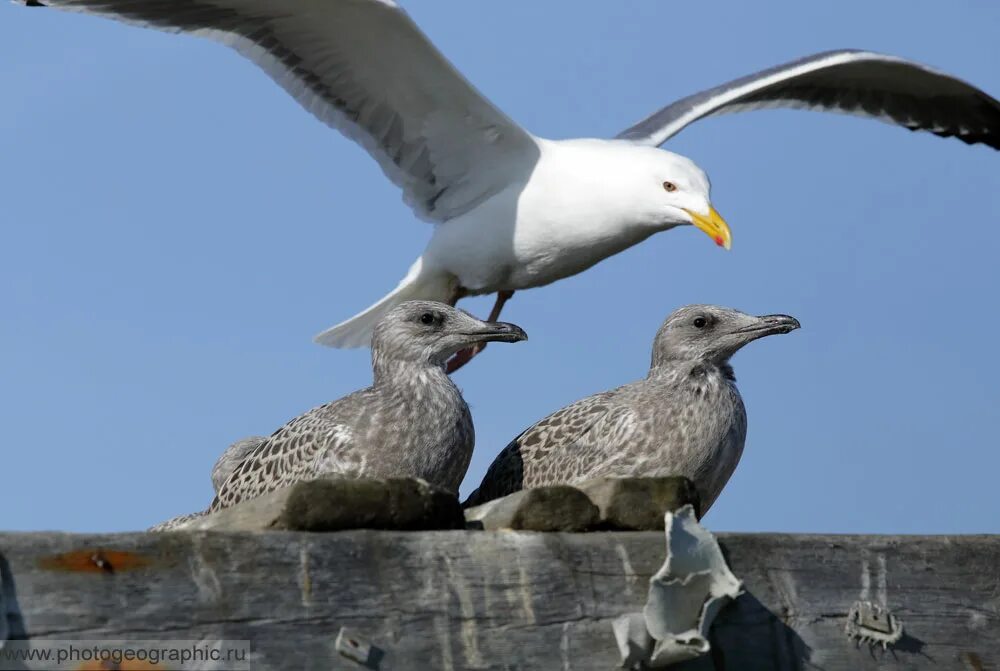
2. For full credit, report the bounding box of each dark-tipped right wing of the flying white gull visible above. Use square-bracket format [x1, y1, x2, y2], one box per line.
[618, 50, 1000, 149]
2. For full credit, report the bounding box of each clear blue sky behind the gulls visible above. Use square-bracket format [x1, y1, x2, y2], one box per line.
[0, 0, 1000, 533]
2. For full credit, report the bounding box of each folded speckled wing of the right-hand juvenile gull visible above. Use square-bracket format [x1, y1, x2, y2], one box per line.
[463, 390, 634, 507]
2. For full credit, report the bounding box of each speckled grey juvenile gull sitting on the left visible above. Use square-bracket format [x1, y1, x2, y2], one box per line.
[209, 301, 527, 511]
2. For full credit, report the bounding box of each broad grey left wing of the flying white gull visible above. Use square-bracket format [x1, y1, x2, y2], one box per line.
[17, 0, 537, 222]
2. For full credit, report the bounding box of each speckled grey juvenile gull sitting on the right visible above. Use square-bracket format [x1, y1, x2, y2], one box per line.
[465, 305, 799, 513]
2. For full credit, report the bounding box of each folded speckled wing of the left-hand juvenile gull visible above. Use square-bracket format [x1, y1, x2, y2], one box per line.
[208, 406, 363, 512]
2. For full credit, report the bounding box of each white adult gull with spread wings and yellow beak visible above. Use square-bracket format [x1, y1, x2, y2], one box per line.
[18, 0, 1000, 370]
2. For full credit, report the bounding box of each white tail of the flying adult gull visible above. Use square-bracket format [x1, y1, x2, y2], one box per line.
[313, 259, 457, 348]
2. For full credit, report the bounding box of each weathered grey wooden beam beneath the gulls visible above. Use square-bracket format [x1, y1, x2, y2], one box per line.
[0, 531, 1000, 671]
